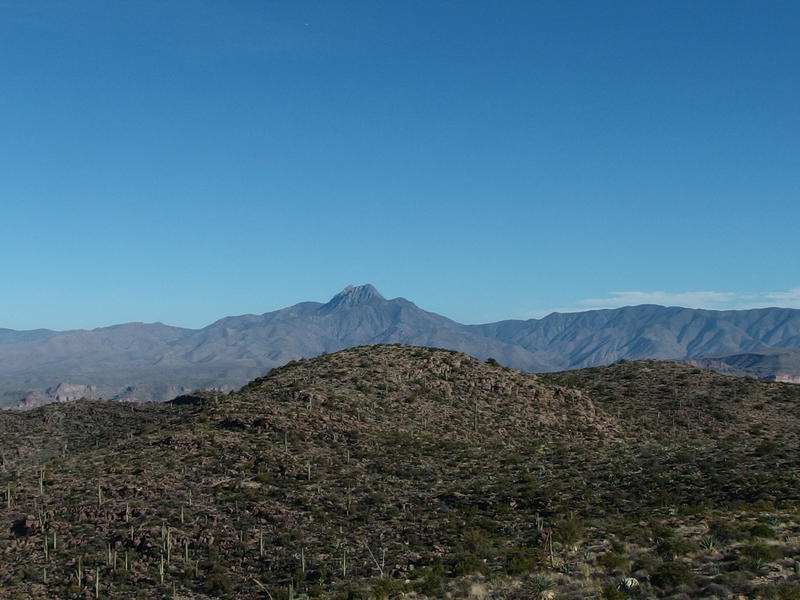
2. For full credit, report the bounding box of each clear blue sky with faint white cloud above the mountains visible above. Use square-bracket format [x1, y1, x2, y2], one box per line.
[0, 0, 800, 329]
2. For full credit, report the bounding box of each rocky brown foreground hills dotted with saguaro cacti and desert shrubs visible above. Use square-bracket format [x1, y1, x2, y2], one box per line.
[0, 345, 800, 600]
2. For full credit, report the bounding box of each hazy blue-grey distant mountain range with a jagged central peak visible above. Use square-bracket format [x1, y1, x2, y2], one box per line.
[0, 285, 800, 406]
